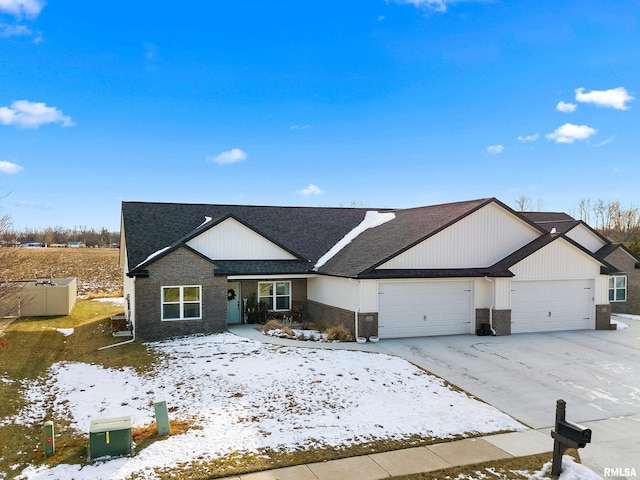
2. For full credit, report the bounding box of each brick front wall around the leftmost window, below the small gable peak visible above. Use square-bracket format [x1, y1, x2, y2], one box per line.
[134, 249, 227, 340]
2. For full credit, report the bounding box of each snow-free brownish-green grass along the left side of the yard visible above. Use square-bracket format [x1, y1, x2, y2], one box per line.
[0, 300, 162, 478]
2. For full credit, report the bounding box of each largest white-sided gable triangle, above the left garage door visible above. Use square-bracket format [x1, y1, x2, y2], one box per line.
[380, 203, 540, 269]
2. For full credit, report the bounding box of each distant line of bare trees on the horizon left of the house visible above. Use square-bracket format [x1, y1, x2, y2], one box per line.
[0, 226, 120, 247]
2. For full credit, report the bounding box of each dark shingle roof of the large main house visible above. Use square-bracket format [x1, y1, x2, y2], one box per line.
[122, 198, 544, 278]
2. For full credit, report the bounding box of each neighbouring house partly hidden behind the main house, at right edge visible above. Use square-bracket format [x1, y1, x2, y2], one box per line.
[523, 212, 640, 315]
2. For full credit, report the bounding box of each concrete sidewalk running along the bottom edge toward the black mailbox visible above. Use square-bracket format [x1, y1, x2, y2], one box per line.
[228, 430, 553, 480]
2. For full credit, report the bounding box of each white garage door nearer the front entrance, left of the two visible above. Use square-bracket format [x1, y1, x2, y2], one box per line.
[378, 281, 473, 338]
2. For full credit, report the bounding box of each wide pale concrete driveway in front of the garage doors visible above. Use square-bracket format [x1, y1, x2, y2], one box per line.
[377, 319, 640, 478]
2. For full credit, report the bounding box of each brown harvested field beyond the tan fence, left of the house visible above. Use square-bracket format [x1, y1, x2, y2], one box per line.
[0, 248, 122, 297]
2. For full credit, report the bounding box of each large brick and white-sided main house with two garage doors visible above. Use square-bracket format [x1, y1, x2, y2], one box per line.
[120, 198, 618, 339]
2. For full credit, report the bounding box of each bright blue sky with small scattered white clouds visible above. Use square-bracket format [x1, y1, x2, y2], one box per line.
[0, 0, 640, 230]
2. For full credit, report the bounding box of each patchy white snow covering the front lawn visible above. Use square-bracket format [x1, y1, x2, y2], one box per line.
[12, 333, 524, 480]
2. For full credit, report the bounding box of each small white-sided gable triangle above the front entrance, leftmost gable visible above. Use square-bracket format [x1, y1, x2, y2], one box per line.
[187, 218, 295, 260]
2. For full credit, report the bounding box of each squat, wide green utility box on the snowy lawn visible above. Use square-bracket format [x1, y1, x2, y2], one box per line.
[89, 417, 133, 459]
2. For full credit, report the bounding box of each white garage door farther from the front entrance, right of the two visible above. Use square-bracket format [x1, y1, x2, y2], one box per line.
[511, 280, 594, 333]
